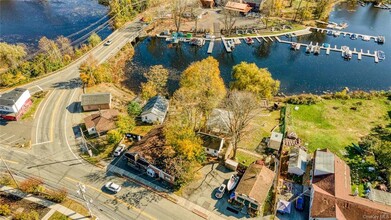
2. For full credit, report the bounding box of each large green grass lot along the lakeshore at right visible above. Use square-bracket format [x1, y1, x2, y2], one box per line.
[287, 98, 391, 155]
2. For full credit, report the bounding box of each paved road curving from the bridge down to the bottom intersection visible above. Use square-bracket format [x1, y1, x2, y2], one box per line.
[0, 19, 205, 219]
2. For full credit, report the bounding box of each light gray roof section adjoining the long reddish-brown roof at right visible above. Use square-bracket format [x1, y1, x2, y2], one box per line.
[314, 150, 334, 176]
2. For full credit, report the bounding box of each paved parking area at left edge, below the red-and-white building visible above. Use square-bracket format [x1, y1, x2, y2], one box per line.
[0, 120, 32, 147]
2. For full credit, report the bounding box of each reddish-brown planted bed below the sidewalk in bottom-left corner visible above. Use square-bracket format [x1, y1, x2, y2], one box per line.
[0, 192, 50, 219]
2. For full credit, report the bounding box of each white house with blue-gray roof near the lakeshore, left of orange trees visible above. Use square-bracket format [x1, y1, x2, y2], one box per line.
[141, 95, 169, 124]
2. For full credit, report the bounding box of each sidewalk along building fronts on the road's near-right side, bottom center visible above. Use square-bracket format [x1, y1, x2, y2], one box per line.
[107, 164, 225, 220]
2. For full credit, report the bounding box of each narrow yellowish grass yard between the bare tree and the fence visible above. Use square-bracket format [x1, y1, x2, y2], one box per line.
[239, 109, 280, 151]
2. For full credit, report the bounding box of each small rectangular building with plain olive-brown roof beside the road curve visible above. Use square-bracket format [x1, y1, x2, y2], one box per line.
[81, 93, 111, 111]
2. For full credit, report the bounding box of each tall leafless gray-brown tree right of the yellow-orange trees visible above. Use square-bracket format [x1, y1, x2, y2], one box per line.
[225, 90, 258, 158]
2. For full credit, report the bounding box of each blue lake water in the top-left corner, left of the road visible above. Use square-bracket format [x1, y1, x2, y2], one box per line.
[0, 0, 111, 49]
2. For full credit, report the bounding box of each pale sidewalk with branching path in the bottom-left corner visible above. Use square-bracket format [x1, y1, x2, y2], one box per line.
[0, 185, 89, 220]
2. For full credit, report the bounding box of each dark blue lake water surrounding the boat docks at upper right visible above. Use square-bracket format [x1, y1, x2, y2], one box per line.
[127, 4, 391, 94]
